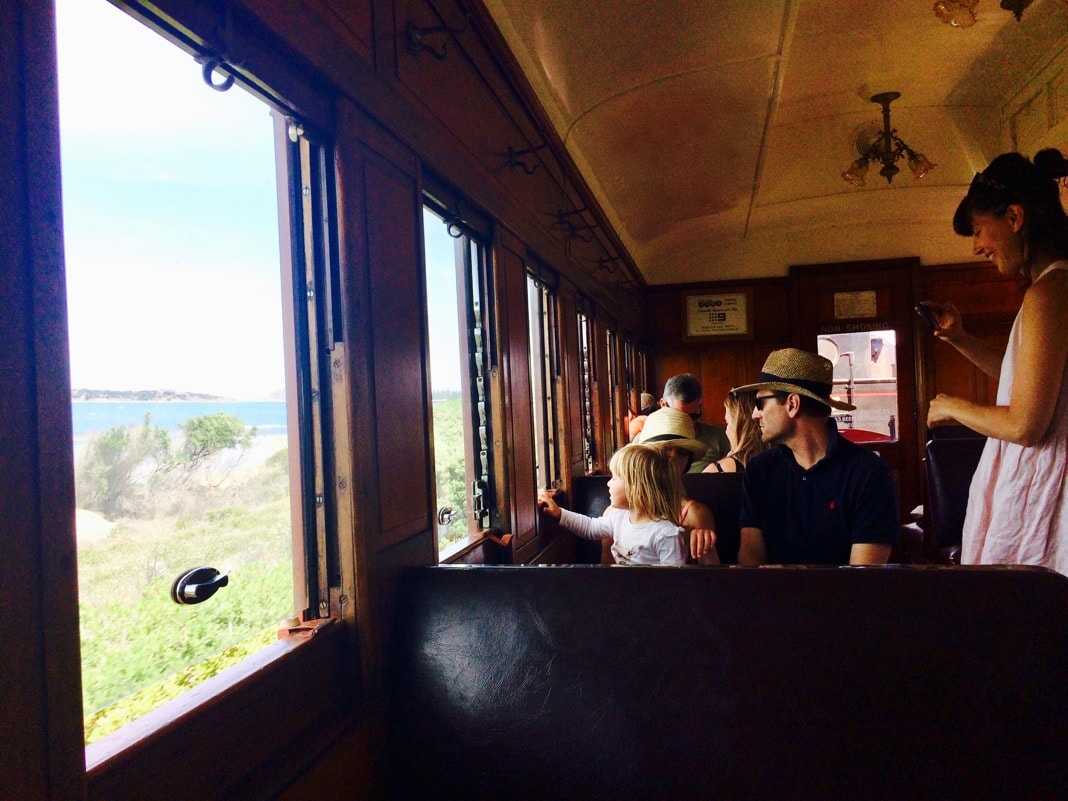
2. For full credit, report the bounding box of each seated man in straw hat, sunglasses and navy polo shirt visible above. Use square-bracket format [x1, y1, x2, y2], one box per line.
[732, 348, 898, 565]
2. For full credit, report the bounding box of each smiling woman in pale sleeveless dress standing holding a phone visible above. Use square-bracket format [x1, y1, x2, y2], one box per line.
[924, 150, 1068, 574]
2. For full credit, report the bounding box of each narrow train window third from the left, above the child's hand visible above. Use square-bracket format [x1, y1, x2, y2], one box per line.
[527, 270, 560, 489]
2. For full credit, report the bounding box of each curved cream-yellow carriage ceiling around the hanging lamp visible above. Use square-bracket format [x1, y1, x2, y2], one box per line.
[484, 0, 1068, 284]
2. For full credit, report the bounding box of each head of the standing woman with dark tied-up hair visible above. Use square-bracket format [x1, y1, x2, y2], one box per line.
[953, 147, 1068, 281]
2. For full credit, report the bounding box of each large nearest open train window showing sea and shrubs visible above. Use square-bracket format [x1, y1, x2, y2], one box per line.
[57, 0, 335, 751]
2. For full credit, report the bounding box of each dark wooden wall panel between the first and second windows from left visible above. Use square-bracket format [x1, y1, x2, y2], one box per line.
[337, 99, 437, 709]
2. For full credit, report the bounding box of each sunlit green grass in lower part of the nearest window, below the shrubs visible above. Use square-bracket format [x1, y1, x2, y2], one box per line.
[78, 440, 294, 744]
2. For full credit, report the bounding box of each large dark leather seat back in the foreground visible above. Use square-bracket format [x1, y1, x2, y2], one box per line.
[383, 565, 1068, 801]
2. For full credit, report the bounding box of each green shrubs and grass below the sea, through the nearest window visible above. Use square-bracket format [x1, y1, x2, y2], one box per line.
[75, 414, 294, 744]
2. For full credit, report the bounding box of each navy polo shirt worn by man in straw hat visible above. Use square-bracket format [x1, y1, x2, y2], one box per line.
[740, 420, 898, 565]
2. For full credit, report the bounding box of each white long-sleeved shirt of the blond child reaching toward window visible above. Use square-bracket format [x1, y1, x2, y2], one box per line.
[560, 506, 686, 565]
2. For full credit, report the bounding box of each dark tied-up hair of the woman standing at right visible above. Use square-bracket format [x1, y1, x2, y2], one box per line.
[953, 147, 1068, 279]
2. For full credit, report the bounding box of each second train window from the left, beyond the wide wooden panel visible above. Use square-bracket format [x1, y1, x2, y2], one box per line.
[423, 200, 497, 560]
